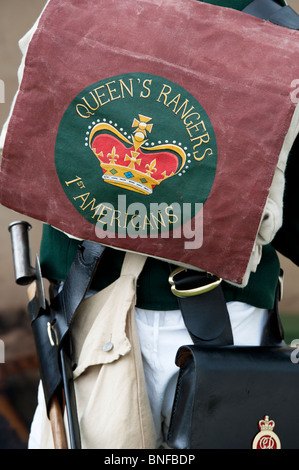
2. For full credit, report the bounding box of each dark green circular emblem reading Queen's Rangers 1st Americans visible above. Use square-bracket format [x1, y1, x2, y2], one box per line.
[55, 73, 217, 236]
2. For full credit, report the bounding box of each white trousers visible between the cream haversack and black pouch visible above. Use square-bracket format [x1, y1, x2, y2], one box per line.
[28, 302, 267, 449]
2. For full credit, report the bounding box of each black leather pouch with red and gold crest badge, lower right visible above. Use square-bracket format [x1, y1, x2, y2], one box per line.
[168, 345, 299, 450]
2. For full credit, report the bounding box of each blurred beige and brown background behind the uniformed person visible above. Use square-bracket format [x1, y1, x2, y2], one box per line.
[0, 0, 299, 449]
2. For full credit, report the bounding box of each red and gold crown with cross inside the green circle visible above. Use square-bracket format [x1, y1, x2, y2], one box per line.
[89, 114, 186, 195]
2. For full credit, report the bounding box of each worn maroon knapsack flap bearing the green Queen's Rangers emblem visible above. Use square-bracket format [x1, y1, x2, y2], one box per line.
[0, 0, 299, 285]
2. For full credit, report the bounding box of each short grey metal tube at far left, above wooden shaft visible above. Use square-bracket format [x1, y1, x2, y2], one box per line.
[8, 221, 36, 286]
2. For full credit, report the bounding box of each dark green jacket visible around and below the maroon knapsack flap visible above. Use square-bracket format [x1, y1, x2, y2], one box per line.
[40, 0, 299, 310]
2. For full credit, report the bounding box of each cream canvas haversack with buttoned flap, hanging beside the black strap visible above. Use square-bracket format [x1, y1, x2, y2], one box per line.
[41, 253, 156, 449]
